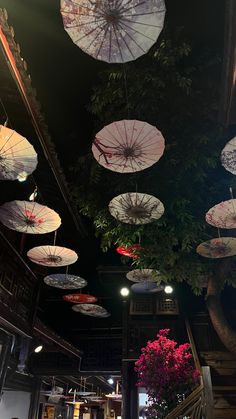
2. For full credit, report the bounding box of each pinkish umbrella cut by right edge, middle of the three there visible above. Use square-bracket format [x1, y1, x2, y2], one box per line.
[206, 199, 236, 228]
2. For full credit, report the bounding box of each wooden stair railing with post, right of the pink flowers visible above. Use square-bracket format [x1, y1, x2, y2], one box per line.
[165, 319, 213, 419]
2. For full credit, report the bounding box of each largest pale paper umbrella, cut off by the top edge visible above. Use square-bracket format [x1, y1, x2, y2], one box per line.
[61, 0, 165, 63]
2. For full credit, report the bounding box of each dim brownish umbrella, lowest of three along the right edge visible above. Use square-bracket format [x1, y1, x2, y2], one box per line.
[197, 237, 236, 259]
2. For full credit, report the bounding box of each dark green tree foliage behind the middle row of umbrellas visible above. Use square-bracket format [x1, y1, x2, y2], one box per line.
[73, 27, 235, 292]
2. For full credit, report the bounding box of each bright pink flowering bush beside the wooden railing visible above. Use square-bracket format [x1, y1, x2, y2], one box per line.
[135, 329, 200, 419]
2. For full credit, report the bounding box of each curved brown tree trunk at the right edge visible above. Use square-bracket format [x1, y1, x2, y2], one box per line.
[206, 259, 236, 356]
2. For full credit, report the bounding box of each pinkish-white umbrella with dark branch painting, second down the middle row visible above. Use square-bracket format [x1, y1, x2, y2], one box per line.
[92, 120, 165, 173]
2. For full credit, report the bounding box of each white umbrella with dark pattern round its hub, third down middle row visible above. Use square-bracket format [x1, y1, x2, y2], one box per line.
[109, 192, 164, 224]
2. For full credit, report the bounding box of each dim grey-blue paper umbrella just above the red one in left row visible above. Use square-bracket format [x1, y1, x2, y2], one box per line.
[44, 274, 87, 290]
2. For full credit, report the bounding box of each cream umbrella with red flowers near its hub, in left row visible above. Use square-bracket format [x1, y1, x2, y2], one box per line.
[0, 201, 61, 234]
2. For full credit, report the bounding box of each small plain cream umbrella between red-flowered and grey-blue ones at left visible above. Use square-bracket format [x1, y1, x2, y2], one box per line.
[27, 246, 78, 267]
